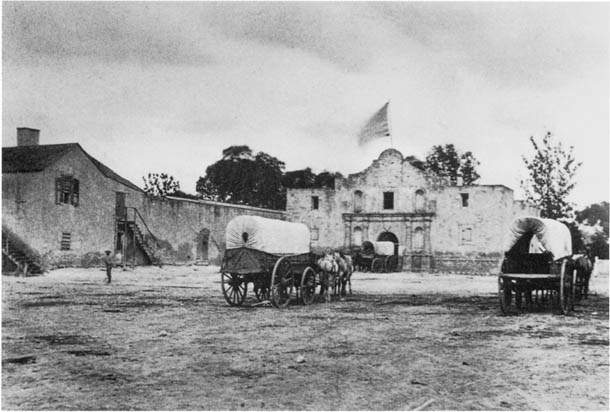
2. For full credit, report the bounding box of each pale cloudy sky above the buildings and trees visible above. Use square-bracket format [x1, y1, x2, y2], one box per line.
[2, 2, 610, 208]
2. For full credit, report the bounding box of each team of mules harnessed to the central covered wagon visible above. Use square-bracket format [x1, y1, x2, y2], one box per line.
[317, 250, 354, 302]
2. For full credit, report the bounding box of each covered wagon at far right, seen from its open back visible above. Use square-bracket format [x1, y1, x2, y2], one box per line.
[498, 217, 576, 314]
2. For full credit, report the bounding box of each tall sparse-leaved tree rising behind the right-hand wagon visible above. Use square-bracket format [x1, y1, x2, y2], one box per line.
[521, 132, 581, 219]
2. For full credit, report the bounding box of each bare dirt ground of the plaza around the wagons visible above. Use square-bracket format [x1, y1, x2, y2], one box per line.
[2, 266, 609, 410]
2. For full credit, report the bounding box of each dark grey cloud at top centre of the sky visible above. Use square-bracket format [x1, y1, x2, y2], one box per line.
[205, 2, 380, 72]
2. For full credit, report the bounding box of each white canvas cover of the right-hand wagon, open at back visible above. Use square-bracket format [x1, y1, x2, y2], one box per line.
[505, 216, 572, 259]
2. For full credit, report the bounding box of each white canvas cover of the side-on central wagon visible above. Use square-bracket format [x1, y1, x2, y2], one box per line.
[225, 215, 310, 254]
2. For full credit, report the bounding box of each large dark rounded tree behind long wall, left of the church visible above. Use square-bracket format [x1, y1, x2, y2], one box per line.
[196, 146, 286, 209]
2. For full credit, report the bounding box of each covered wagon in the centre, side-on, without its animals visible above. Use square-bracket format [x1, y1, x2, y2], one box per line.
[220, 216, 319, 307]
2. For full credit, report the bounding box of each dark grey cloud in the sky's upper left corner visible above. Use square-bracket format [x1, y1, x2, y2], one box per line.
[3, 2, 213, 65]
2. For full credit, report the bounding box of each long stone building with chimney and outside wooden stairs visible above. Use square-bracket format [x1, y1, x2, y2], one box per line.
[2, 128, 284, 272]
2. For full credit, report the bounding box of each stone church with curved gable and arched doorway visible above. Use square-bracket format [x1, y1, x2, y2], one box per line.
[286, 149, 539, 271]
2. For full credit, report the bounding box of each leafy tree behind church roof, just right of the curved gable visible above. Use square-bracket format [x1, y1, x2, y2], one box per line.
[424, 144, 481, 186]
